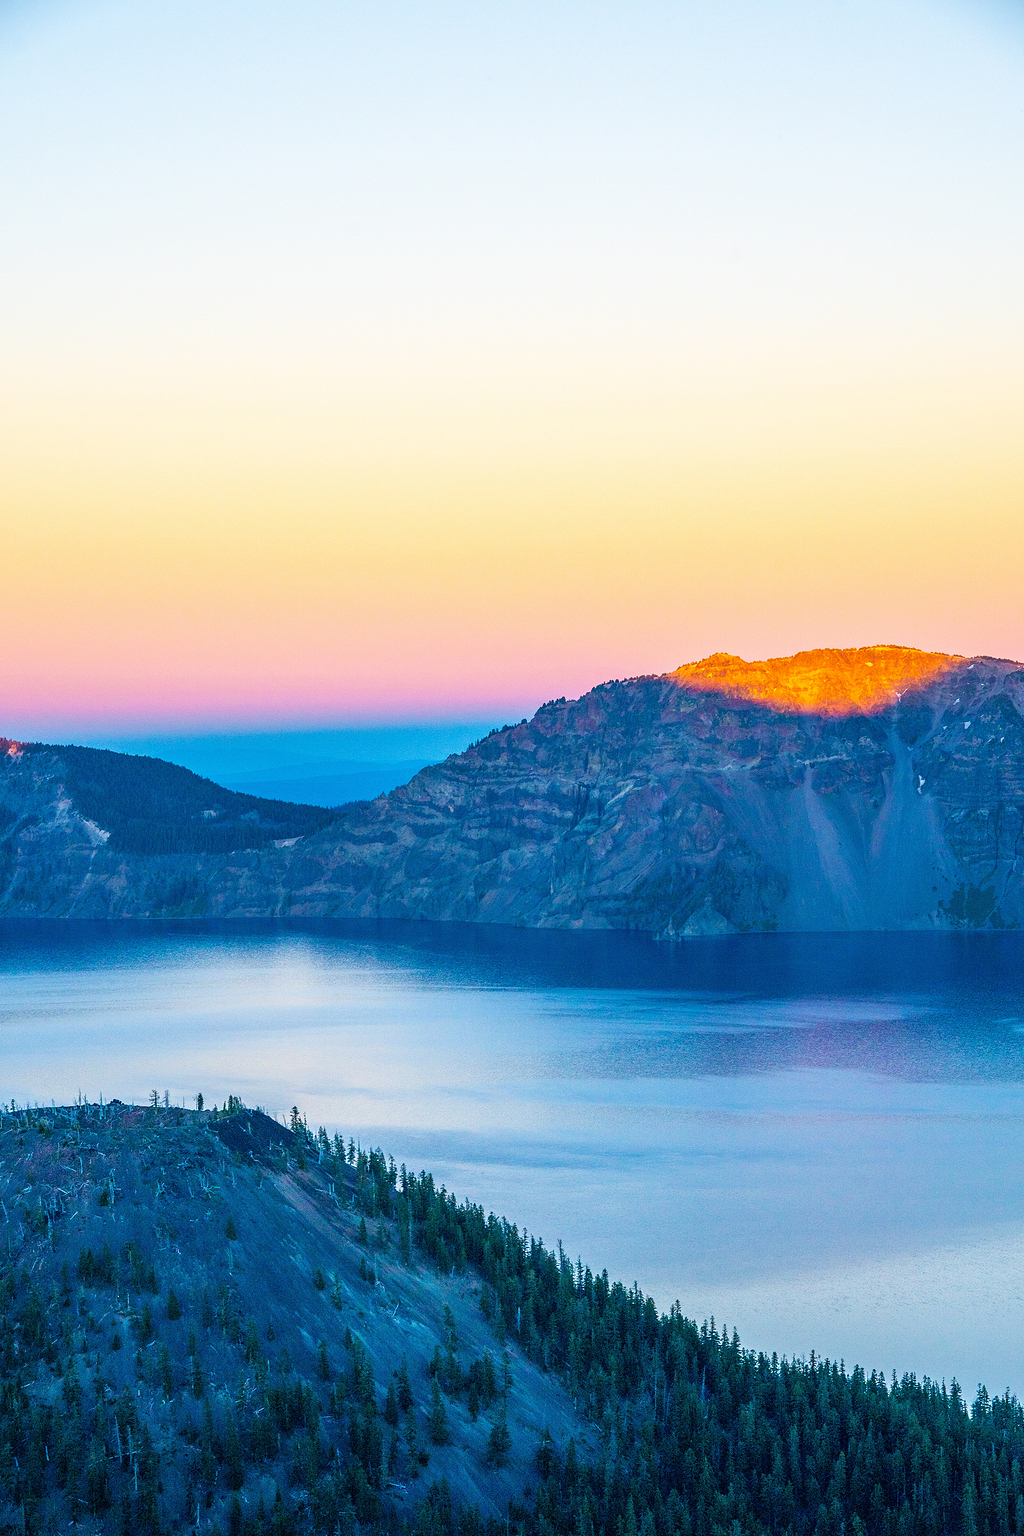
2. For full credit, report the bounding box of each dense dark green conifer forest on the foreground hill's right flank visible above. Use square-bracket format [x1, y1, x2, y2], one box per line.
[293, 1124, 1024, 1536]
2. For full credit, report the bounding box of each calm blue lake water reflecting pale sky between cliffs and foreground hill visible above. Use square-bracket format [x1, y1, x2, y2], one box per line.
[0, 923, 1024, 1395]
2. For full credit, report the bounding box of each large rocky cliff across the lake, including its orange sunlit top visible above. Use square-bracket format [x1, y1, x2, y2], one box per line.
[2, 647, 1024, 938]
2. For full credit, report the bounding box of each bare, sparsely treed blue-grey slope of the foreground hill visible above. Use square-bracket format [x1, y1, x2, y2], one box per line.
[0, 1095, 594, 1536]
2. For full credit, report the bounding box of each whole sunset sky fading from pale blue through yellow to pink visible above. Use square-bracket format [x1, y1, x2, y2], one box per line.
[0, 0, 1024, 737]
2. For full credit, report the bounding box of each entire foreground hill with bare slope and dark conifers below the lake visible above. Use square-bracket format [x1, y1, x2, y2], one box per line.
[0, 1095, 1024, 1536]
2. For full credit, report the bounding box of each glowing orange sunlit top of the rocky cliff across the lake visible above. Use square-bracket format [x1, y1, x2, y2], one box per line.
[669, 645, 964, 716]
